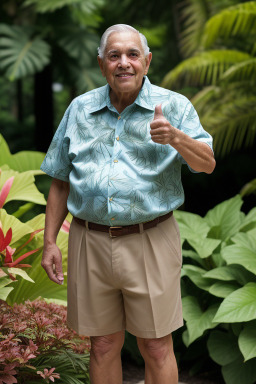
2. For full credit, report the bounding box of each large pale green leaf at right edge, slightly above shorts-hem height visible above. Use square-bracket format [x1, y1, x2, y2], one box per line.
[213, 283, 256, 323]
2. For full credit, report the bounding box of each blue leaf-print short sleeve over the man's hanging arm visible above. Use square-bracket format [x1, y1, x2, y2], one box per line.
[40, 104, 73, 181]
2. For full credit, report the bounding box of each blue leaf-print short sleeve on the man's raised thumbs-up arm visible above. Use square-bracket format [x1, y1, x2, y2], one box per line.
[179, 101, 213, 173]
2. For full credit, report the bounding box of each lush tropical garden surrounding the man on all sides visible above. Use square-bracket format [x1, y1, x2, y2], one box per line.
[0, 0, 256, 384]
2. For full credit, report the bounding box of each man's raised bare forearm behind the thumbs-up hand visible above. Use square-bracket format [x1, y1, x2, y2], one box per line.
[170, 129, 215, 173]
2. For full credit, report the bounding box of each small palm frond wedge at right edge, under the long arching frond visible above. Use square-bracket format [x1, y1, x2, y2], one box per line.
[221, 58, 256, 83]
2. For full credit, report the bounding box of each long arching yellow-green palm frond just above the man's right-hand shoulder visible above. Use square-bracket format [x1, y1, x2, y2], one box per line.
[162, 50, 251, 89]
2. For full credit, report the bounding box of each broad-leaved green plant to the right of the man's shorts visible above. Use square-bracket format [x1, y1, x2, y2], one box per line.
[175, 196, 256, 384]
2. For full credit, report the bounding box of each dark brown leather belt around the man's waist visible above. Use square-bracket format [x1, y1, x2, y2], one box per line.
[74, 211, 173, 237]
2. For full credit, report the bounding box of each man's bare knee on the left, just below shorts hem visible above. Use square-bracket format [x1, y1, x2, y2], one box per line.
[91, 335, 124, 360]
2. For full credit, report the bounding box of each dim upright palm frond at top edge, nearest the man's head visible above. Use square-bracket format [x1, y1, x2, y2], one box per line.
[179, 0, 211, 57]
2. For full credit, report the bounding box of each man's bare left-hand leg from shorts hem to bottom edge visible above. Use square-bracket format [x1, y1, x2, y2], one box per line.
[90, 331, 124, 384]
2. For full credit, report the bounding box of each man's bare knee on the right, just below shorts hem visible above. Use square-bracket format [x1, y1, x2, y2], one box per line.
[137, 335, 173, 367]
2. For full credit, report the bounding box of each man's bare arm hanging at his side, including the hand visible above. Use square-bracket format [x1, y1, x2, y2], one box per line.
[41, 179, 69, 284]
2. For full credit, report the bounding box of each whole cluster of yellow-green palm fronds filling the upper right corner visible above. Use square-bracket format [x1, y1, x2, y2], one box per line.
[162, 0, 256, 156]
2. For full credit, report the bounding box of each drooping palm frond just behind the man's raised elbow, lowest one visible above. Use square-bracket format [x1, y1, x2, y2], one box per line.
[201, 95, 256, 156]
